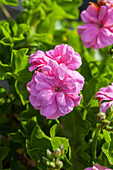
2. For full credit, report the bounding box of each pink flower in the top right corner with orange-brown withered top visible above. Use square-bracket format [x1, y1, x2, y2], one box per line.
[78, 3, 113, 50]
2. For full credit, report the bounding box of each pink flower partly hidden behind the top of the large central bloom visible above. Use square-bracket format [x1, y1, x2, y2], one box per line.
[29, 44, 82, 71]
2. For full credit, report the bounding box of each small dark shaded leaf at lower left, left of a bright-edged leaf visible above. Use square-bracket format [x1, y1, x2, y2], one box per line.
[8, 129, 25, 143]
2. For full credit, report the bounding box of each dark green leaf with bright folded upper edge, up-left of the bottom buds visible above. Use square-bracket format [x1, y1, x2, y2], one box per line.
[31, 125, 52, 153]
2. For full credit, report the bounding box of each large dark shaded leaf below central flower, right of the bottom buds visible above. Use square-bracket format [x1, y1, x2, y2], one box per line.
[62, 108, 91, 170]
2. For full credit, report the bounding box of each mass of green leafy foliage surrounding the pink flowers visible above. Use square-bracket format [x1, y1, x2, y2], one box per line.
[0, 0, 113, 170]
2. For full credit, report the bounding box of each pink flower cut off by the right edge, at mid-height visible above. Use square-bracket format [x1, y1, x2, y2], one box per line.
[96, 83, 113, 113]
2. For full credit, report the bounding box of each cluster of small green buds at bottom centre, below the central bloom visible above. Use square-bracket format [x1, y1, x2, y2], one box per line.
[43, 145, 64, 170]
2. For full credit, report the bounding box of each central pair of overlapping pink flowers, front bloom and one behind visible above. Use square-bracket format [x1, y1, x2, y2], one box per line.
[27, 44, 84, 119]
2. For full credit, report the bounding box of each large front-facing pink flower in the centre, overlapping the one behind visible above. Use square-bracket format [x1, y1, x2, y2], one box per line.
[27, 60, 84, 119]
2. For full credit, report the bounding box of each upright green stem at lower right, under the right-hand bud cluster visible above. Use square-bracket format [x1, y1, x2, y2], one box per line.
[92, 124, 102, 160]
